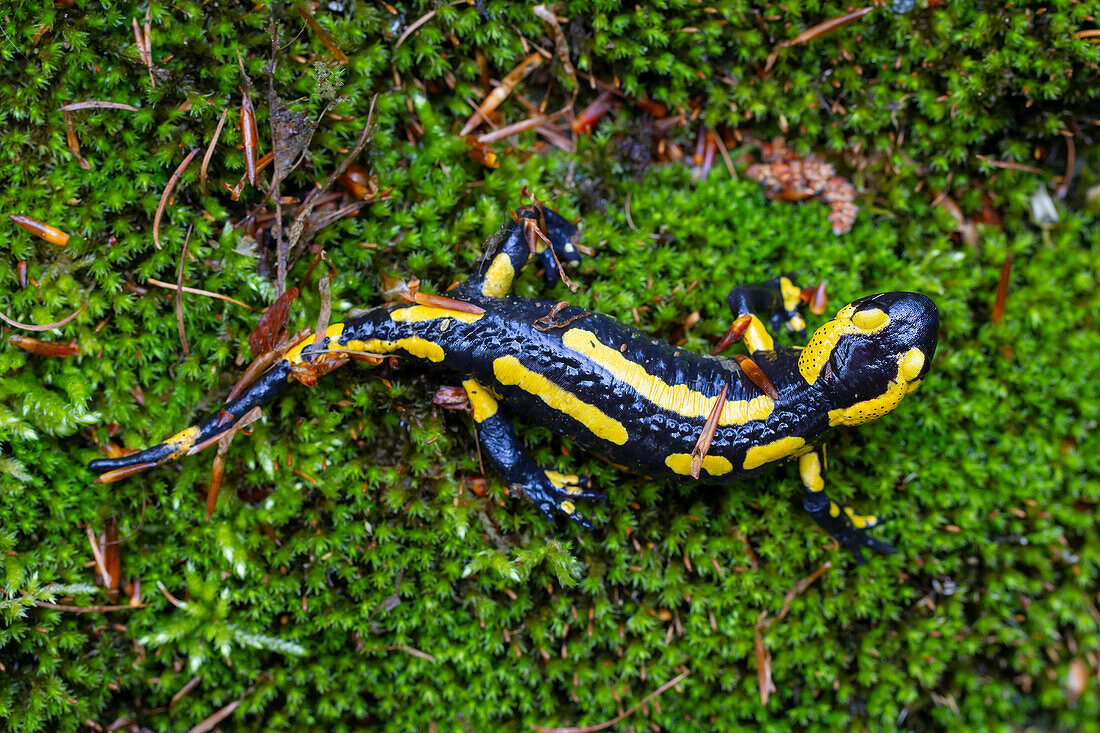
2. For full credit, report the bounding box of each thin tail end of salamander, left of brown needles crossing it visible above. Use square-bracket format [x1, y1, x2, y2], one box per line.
[88, 360, 294, 483]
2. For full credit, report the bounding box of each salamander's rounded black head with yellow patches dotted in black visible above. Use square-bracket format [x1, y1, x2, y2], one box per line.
[799, 293, 939, 425]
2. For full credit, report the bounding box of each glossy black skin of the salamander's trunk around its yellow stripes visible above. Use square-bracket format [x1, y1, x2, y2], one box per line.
[340, 296, 828, 483]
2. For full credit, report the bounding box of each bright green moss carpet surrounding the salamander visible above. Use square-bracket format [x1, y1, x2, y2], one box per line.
[0, 0, 1100, 731]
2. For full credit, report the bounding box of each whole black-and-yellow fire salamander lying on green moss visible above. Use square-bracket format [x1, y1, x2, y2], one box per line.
[89, 206, 939, 562]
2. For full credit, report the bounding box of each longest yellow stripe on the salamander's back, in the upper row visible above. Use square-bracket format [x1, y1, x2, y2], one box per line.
[561, 328, 776, 425]
